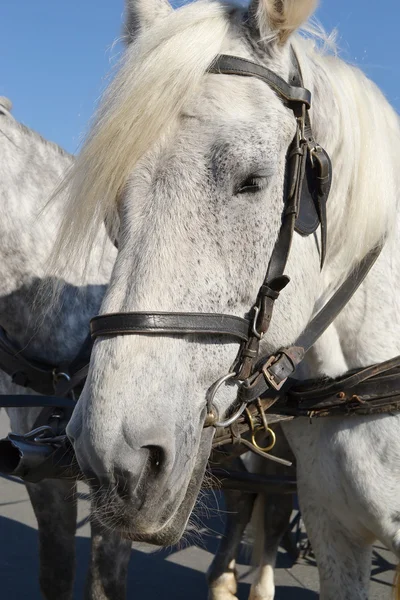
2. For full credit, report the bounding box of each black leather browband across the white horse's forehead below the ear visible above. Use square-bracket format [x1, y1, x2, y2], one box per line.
[208, 54, 311, 108]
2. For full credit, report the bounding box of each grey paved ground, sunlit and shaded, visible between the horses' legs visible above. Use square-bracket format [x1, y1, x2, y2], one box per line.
[0, 416, 395, 600]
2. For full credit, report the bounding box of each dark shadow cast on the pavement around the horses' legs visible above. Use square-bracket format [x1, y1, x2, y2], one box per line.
[0, 510, 317, 600]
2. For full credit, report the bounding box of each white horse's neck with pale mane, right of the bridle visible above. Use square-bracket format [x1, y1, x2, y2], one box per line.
[296, 42, 400, 375]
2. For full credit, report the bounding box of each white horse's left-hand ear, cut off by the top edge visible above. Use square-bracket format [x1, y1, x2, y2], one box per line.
[124, 0, 172, 44]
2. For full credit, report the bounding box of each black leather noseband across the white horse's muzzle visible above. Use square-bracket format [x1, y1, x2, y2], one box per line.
[90, 312, 249, 341]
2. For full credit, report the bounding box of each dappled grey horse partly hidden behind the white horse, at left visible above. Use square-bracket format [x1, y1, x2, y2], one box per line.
[0, 99, 136, 600]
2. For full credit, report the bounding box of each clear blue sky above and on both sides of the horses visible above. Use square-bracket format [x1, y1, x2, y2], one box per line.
[0, 0, 400, 152]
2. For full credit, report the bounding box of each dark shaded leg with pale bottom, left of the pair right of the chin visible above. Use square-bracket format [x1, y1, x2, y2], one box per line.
[207, 490, 256, 600]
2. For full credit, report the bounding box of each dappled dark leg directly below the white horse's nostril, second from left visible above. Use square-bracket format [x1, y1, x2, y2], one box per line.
[85, 517, 132, 600]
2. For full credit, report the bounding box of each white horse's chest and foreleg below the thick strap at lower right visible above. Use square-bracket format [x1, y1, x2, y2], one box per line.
[285, 416, 400, 600]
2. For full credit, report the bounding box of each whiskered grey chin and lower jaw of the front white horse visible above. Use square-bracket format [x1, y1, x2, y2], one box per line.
[92, 429, 213, 546]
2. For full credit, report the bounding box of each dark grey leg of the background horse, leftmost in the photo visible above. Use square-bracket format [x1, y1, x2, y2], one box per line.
[26, 480, 77, 600]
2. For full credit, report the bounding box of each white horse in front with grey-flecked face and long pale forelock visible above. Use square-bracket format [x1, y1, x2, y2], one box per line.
[50, 0, 400, 600]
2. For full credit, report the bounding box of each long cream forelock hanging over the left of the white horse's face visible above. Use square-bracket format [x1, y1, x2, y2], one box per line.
[51, 0, 232, 271]
